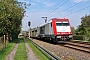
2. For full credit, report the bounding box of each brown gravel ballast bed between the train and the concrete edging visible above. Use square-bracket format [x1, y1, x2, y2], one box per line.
[32, 39, 90, 60]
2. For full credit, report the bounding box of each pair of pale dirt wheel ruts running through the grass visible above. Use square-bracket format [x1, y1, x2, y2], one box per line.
[5, 40, 38, 60]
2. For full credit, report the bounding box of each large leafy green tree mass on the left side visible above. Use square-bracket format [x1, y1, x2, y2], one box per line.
[0, 0, 27, 38]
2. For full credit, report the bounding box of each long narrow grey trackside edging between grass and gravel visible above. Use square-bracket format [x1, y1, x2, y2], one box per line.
[30, 40, 61, 60]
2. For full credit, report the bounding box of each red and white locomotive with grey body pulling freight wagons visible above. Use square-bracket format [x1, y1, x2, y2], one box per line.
[30, 18, 72, 43]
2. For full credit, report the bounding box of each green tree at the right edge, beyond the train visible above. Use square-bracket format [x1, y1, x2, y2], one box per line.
[77, 14, 90, 35]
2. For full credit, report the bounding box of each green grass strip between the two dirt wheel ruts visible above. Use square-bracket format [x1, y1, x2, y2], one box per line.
[14, 38, 27, 60]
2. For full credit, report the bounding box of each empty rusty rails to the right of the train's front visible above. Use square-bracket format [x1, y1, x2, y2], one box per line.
[59, 42, 90, 53]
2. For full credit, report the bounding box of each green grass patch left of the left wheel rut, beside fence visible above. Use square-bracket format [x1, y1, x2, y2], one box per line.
[0, 42, 15, 60]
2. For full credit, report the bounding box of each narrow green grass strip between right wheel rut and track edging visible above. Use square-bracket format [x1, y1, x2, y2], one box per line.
[26, 38, 51, 60]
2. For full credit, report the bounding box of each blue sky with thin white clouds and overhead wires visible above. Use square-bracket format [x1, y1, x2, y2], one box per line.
[19, 0, 90, 31]
